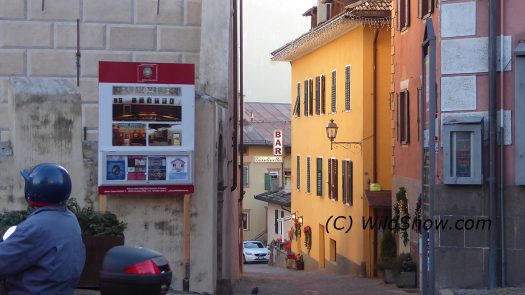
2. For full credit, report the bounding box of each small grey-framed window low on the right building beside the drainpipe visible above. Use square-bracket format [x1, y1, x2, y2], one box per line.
[443, 118, 483, 184]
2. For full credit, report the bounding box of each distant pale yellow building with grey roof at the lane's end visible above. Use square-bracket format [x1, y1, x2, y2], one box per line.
[242, 102, 291, 242]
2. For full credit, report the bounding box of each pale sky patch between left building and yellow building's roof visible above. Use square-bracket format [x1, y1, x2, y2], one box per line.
[243, 0, 317, 103]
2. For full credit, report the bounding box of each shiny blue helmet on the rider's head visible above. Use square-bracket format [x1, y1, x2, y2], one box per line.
[20, 163, 71, 207]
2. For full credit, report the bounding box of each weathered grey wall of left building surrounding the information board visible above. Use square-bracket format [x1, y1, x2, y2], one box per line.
[0, 0, 240, 293]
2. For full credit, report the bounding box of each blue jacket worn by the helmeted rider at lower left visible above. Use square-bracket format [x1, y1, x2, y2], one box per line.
[0, 206, 86, 295]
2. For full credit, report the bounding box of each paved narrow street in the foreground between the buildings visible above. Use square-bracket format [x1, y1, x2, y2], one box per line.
[234, 264, 419, 295]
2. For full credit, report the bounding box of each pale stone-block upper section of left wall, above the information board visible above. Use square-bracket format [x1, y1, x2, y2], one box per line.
[0, 0, 202, 142]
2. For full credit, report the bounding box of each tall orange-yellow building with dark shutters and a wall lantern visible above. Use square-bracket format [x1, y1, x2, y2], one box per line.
[272, 0, 392, 276]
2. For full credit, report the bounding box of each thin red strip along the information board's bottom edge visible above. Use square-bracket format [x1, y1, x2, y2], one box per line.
[98, 185, 194, 195]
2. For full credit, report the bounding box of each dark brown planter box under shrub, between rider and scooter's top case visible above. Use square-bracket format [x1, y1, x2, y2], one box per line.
[78, 236, 124, 288]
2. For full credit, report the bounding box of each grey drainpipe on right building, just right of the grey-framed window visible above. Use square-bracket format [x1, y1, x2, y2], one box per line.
[488, 0, 499, 289]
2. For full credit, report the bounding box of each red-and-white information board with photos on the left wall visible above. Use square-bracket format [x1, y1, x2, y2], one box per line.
[98, 62, 195, 194]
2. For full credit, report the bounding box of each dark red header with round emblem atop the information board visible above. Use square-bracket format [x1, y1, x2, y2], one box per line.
[98, 61, 195, 85]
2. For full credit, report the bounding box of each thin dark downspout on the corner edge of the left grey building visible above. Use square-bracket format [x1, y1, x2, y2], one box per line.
[230, 0, 239, 192]
